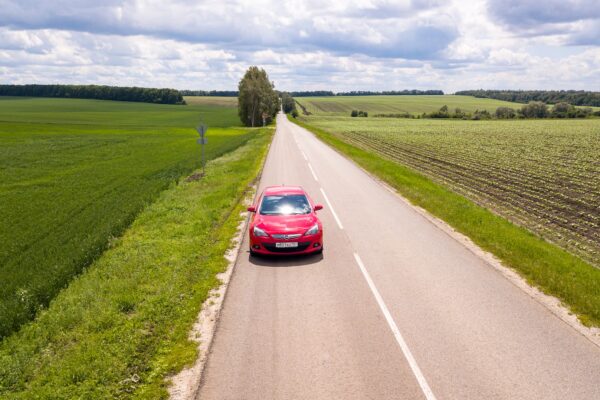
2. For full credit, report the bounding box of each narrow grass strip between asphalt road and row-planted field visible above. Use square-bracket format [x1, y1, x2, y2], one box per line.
[292, 115, 600, 326]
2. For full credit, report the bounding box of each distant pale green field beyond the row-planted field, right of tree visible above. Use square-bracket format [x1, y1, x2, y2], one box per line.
[295, 95, 522, 116]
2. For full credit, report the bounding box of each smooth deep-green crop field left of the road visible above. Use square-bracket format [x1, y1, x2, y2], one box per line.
[0, 98, 253, 338]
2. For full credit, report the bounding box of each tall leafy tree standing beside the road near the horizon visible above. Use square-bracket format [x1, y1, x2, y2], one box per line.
[238, 66, 279, 127]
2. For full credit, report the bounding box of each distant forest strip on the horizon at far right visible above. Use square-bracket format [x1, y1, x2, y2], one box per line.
[455, 89, 600, 107]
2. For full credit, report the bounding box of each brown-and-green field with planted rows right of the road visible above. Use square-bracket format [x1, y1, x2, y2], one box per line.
[302, 115, 600, 267]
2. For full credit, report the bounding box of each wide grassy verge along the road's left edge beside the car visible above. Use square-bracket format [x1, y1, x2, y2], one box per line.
[0, 128, 272, 400]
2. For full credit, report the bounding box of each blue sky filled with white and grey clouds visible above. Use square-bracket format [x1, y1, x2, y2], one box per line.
[0, 0, 600, 92]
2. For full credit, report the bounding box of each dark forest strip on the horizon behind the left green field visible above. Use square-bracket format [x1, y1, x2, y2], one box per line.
[0, 85, 185, 104]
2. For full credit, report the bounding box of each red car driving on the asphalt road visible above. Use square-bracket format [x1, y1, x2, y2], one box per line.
[248, 186, 323, 255]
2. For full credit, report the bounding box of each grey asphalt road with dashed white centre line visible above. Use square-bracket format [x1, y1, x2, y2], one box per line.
[199, 115, 600, 400]
